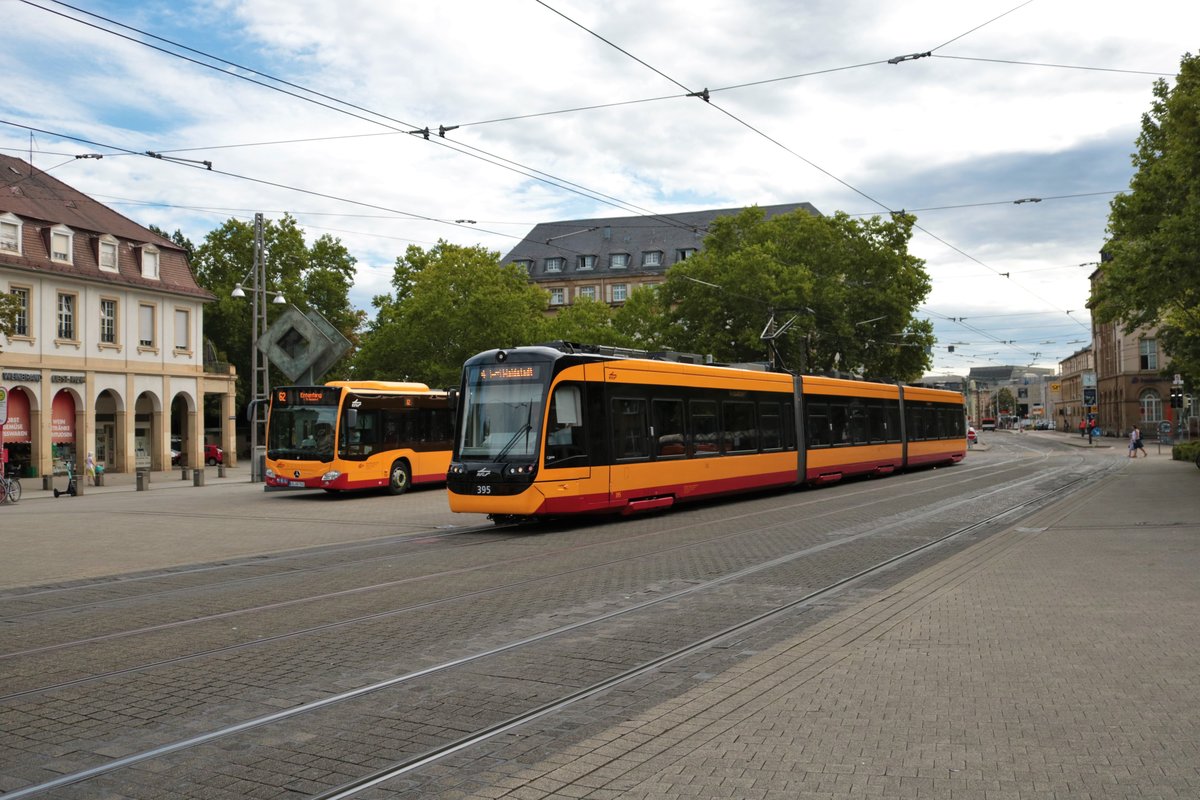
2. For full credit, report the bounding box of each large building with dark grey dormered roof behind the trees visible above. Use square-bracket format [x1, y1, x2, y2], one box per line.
[504, 203, 821, 309]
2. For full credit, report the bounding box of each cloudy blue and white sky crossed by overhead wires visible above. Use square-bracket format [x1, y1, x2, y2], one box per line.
[0, 0, 1200, 374]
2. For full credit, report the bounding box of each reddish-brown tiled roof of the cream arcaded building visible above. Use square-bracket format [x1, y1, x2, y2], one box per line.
[0, 154, 214, 300]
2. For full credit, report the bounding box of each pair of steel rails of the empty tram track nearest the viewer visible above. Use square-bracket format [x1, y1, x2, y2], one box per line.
[0, 448, 1113, 798]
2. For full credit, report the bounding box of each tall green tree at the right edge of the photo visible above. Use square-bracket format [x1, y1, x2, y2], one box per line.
[1091, 53, 1200, 386]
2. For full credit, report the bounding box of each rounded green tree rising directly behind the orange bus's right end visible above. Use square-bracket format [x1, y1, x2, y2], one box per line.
[354, 241, 547, 386]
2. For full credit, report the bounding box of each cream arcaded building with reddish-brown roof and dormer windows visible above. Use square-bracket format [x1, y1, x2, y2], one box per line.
[0, 155, 235, 476]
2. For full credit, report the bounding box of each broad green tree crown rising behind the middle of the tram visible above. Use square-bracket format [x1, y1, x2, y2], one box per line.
[660, 209, 934, 380]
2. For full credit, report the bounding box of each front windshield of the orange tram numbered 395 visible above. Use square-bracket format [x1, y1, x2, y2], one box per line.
[458, 363, 546, 462]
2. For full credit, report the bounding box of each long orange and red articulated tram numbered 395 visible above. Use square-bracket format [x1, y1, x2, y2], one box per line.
[446, 343, 967, 519]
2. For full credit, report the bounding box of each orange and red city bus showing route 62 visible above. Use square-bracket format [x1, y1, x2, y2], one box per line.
[263, 380, 454, 494]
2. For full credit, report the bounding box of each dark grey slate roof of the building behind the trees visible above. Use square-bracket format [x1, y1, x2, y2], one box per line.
[503, 203, 821, 281]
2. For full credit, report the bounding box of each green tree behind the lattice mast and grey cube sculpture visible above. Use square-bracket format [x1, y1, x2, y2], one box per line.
[192, 215, 365, 405]
